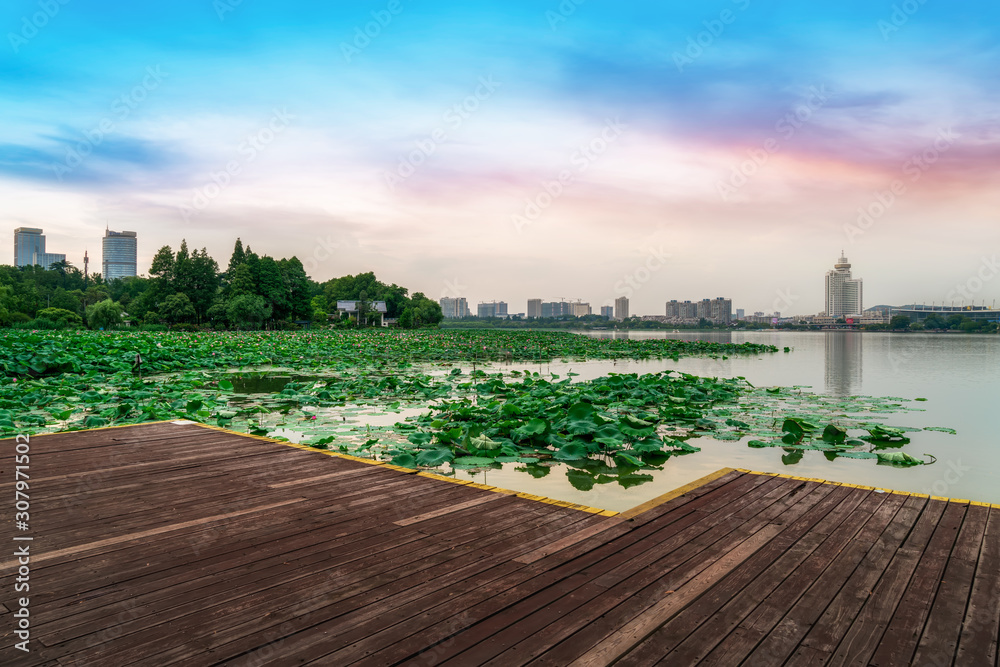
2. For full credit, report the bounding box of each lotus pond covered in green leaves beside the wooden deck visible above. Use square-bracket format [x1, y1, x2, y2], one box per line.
[0, 330, 968, 509]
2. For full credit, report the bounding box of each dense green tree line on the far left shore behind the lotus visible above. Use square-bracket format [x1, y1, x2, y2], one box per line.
[0, 239, 442, 329]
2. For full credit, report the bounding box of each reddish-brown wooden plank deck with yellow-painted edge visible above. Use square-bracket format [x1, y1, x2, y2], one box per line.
[0, 423, 1000, 667]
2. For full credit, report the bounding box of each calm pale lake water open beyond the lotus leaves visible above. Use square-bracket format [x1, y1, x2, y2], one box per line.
[456, 331, 1000, 511]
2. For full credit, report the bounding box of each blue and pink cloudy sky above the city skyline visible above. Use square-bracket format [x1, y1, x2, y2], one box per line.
[0, 0, 1000, 314]
